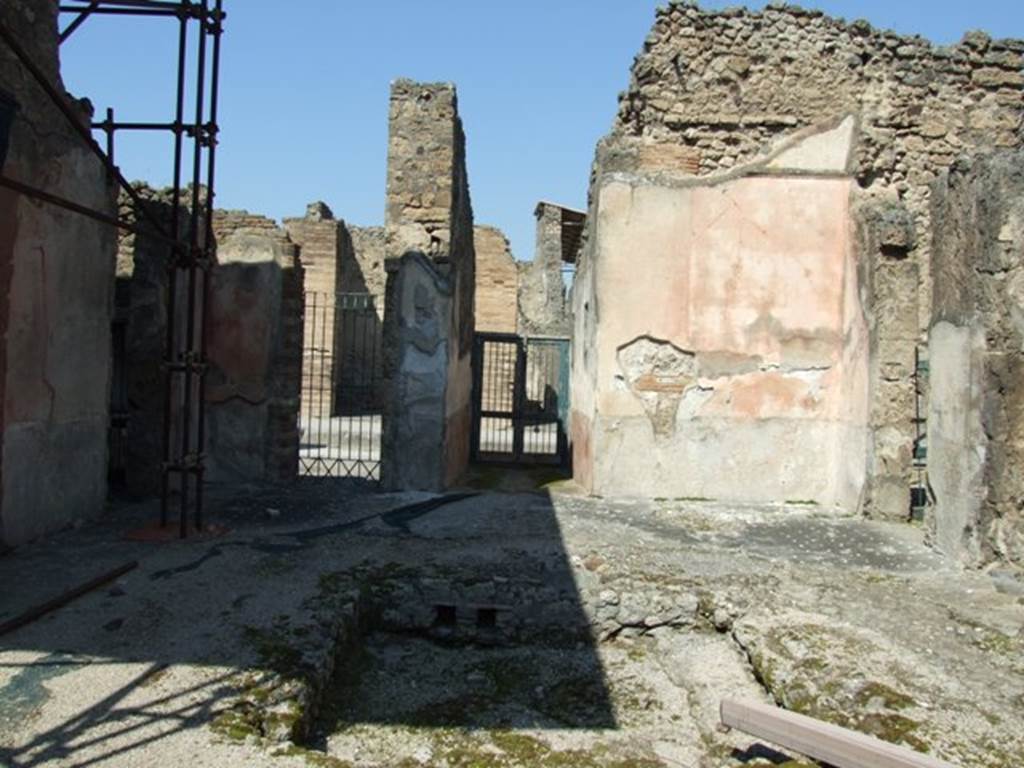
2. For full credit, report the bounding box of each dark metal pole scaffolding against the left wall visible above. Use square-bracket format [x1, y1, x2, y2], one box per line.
[0, 0, 225, 538]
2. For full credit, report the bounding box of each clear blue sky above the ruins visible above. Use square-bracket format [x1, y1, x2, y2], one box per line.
[62, 0, 1024, 259]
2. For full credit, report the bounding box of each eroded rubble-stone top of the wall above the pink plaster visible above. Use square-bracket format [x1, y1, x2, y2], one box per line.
[614, 2, 1024, 183]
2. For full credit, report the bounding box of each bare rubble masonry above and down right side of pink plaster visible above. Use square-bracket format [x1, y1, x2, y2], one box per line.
[578, 2, 1024, 519]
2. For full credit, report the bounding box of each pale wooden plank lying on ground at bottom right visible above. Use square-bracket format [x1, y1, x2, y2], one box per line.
[720, 698, 954, 768]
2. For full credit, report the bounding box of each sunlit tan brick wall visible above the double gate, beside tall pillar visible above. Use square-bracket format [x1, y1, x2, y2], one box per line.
[473, 225, 519, 334]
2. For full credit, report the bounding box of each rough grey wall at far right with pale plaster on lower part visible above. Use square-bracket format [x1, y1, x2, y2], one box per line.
[928, 151, 1024, 566]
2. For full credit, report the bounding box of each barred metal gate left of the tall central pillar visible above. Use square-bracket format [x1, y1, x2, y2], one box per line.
[299, 292, 383, 480]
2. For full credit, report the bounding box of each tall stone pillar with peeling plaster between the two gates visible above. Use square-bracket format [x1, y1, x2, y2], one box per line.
[381, 80, 476, 490]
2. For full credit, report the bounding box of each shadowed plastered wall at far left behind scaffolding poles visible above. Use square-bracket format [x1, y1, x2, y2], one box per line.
[0, 0, 117, 545]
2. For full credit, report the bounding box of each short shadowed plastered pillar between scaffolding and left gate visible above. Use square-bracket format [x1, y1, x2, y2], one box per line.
[206, 228, 303, 482]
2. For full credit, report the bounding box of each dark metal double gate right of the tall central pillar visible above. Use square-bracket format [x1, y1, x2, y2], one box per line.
[473, 333, 569, 465]
